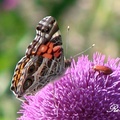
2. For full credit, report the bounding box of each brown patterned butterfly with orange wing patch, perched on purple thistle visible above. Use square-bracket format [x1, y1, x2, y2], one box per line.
[11, 16, 71, 99]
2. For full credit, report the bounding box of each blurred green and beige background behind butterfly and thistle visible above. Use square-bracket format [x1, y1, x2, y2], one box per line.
[0, 0, 120, 120]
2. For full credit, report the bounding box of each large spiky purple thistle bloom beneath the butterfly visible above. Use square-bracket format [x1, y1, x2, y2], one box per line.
[19, 53, 120, 120]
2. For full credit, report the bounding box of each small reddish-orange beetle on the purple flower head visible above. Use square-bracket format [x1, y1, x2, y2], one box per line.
[93, 65, 113, 75]
